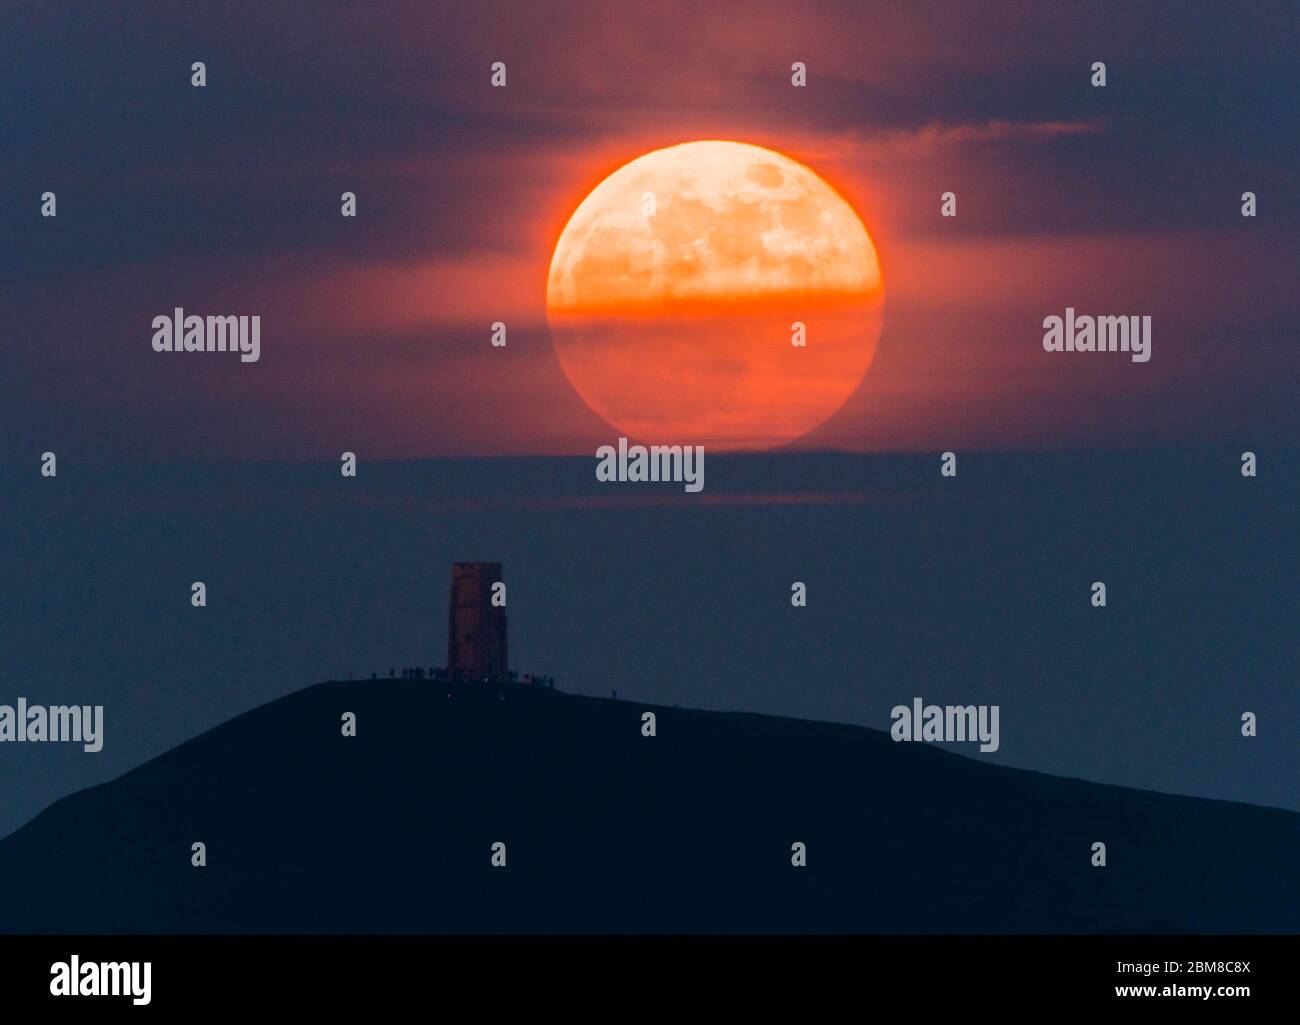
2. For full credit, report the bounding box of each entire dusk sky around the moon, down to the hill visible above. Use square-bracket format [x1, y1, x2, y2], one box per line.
[0, 3, 1300, 835]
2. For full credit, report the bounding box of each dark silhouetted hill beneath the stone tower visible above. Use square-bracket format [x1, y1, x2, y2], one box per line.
[0, 680, 1300, 933]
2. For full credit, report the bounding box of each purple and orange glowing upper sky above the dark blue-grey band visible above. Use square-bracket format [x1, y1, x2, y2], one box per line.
[0, 3, 1300, 463]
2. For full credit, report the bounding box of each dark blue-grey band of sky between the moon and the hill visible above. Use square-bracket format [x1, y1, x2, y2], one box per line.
[0, 449, 1300, 832]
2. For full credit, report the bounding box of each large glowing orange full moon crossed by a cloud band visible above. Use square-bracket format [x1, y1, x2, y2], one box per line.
[546, 140, 884, 449]
